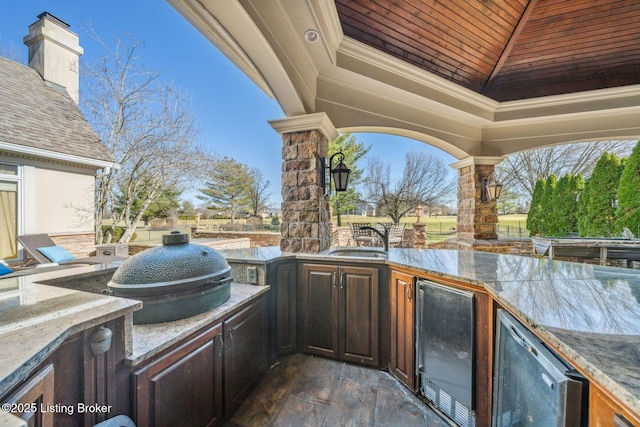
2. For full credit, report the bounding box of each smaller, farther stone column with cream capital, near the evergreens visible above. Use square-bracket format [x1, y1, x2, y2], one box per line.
[451, 157, 502, 241]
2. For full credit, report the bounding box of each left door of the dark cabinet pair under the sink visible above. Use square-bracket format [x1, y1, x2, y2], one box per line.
[301, 264, 339, 358]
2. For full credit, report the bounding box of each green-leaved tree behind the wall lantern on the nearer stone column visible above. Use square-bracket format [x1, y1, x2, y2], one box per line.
[329, 133, 370, 226]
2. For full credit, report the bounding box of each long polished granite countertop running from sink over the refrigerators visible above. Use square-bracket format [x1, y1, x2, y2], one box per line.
[221, 248, 640, 422]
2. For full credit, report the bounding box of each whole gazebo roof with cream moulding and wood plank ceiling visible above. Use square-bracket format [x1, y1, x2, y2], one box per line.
[169, 0, 640, 159]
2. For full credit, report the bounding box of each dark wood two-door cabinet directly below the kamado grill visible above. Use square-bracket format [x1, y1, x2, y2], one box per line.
[132, 297, 269, 427]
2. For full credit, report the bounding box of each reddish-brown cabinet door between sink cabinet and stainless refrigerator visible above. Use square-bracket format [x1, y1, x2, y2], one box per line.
[389, 271, 415, 390]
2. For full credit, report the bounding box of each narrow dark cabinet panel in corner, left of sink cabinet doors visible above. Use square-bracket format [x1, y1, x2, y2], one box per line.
[275, 263, 298, 356]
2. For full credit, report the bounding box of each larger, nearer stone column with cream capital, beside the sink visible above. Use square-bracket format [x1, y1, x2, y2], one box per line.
[269, 113, 338, 253]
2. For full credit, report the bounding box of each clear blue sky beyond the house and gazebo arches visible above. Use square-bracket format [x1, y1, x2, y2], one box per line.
[0, 0, 455, 206]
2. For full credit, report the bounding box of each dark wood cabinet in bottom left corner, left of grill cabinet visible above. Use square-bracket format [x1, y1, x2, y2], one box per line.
[0, 317, 130, 427]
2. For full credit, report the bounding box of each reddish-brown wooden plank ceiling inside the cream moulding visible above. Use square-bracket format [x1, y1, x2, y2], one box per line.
[336, 0, 640, 101]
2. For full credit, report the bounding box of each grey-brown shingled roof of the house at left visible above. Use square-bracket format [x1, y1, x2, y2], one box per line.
[0, 58, 113, 164]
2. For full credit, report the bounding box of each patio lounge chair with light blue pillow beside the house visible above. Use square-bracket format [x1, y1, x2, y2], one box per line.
[18, 234, 126, 265]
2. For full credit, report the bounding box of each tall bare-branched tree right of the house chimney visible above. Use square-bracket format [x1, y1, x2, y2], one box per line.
[81, 33, 208, 242]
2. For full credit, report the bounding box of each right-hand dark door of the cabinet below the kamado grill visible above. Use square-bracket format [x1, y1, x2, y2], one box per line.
[224, 298, 269, 415]
